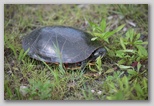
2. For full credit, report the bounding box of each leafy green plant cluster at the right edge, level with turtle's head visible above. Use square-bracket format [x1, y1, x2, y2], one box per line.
[116, 29, 148, 64]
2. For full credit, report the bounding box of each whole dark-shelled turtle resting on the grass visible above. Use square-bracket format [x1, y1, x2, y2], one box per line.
[22, 26, 106, 68]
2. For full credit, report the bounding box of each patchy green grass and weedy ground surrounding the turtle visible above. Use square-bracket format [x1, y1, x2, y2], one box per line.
[4, 4, 148, 100]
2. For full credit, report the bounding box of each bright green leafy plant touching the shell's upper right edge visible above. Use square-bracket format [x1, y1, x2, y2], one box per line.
[89, 19, 125, 43]
